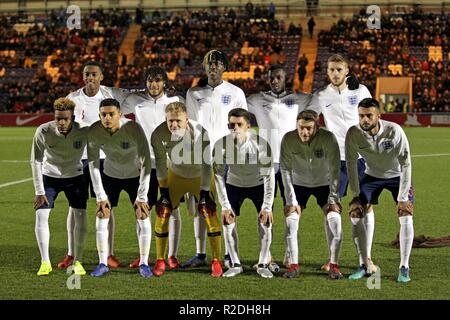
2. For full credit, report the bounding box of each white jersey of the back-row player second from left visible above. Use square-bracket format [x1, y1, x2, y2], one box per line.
[121, 91, 184, 168]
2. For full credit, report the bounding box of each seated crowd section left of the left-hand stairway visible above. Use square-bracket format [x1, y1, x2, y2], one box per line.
[0, 8, 131, 112]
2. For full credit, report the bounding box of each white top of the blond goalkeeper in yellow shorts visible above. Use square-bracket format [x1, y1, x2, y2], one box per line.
[151, 120, 211, 190]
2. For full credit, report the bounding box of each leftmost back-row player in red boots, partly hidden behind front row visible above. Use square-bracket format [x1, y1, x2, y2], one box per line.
[58, 61, 127, 269]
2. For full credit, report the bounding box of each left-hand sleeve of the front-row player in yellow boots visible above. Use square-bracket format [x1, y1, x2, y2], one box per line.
[30, 127, 45, 196]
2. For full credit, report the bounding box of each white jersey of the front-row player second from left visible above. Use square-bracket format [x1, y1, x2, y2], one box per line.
[88, 119, 151, 201]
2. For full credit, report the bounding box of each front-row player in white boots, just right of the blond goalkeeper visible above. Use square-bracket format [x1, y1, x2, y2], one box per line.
[213, 108, 275, 278]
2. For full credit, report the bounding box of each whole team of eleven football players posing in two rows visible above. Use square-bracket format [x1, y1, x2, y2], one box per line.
[25, 50, 414, 283]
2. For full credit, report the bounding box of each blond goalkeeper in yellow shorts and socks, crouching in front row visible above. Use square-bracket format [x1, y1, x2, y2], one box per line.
[151, 102, 223, 277]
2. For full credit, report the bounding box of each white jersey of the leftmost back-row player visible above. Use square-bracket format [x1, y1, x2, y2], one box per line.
[66, 86, 129, 159]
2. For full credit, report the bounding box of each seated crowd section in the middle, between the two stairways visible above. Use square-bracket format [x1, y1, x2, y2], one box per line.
[120, 2, 302, 94]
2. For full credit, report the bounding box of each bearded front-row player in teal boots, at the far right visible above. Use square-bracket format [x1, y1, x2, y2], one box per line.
[345, 98, 414, 282]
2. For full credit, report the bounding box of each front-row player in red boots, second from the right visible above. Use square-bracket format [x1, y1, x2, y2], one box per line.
[281, 110, 343, 279]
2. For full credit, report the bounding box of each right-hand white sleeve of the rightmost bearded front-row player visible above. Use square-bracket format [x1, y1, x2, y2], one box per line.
[397, 128, 412, 201]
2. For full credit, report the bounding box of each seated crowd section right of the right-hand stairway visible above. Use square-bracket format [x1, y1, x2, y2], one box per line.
[314, 7, 450, 112]
